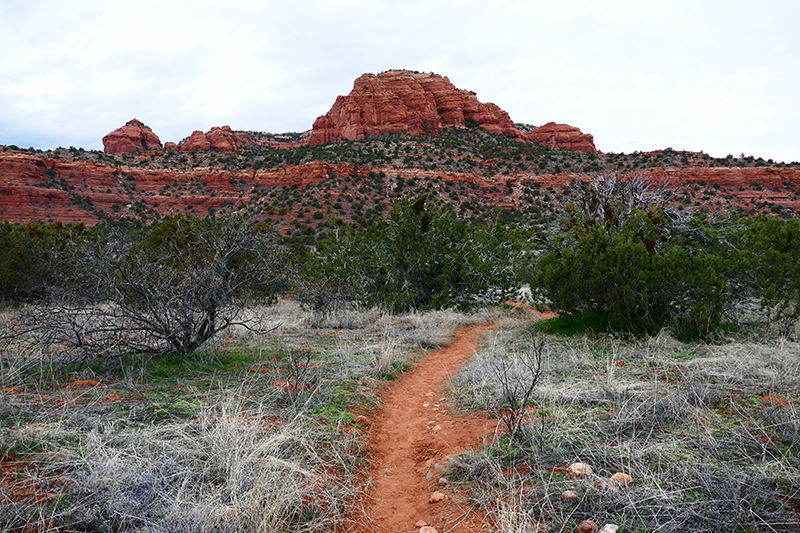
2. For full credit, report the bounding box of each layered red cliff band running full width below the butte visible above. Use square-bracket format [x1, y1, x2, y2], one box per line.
[0, 144, 800, 230]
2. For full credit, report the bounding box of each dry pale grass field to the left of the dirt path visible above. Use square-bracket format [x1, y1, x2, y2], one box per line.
[0, 301, 500, 532]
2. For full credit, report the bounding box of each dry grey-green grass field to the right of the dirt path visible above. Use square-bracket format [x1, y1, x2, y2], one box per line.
[449, 325, 800, 532]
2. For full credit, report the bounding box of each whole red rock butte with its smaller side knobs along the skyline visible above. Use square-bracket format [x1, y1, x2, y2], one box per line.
[103, 70, 597, 154]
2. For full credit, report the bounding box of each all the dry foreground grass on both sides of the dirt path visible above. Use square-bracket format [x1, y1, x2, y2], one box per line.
[0, 301, 800, 532]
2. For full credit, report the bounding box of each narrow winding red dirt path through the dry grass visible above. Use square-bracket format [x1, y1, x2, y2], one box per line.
[350, 324, 497, 533]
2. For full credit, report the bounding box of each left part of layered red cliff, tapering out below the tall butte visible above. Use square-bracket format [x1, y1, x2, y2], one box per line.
[0, 152, 368, 226]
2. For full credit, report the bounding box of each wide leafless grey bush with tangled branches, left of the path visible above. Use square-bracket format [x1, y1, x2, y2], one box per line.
[12, 218, 288, 358]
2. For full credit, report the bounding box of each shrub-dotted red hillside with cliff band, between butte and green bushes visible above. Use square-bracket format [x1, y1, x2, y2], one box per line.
[0, 127, 800, 233]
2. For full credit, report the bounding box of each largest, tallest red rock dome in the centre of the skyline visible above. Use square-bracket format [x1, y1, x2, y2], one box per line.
[310, 70, 524, 146]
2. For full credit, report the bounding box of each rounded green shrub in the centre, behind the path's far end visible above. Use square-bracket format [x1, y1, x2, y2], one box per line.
[306, 196, 514, 312]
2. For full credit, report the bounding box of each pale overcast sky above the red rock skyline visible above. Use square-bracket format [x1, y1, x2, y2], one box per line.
[0, 0, 800, 163]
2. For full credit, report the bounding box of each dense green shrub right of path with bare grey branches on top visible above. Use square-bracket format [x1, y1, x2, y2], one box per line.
[532, 177, 729, 337]
